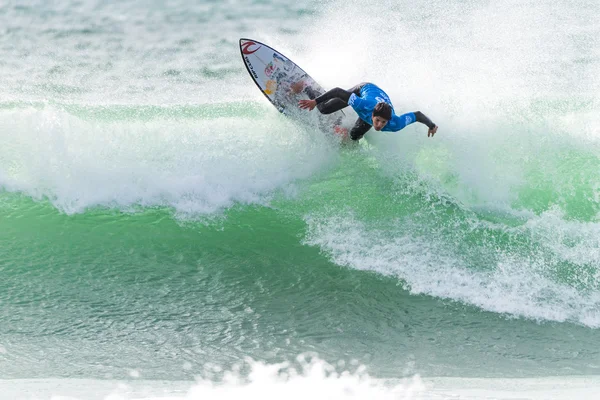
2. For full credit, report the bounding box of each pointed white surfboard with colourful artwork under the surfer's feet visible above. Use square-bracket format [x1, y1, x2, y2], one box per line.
[240, 38, 347, 136]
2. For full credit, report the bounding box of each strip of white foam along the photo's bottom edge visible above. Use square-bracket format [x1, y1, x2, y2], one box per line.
[0, 358, 600, 400]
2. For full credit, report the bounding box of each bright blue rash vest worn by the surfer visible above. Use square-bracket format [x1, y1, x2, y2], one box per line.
[348, 83, 417, 132]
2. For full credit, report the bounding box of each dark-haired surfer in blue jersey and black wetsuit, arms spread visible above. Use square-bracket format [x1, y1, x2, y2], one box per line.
[298, 82, 438, 140]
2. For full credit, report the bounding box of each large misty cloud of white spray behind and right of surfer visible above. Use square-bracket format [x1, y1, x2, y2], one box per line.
[301, 0, 600, 211]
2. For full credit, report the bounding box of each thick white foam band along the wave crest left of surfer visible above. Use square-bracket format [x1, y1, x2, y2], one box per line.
[0, 104, 335, 214]
